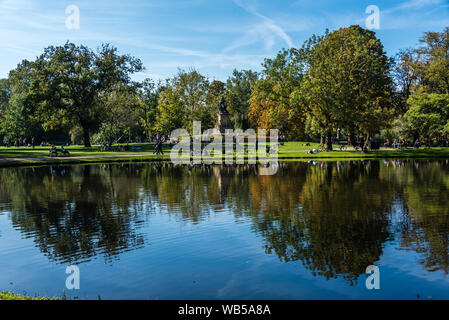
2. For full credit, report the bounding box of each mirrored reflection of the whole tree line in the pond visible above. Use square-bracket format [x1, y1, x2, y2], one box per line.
[0, 160, 449, 284]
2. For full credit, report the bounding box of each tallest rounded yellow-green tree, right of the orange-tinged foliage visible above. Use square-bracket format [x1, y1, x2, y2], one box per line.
[294, 25, 392, 150]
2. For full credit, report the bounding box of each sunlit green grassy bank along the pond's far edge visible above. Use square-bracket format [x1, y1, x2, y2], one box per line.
[0, 142, 449, 167]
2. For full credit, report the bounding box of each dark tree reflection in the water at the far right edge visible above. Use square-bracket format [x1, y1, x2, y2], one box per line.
[394, 160, 449, 274]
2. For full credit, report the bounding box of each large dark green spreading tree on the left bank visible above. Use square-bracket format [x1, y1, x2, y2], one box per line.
[28, 42, 143, 147]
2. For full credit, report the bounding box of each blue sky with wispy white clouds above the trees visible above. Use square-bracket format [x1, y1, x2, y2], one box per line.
[0, 0, 449, 80]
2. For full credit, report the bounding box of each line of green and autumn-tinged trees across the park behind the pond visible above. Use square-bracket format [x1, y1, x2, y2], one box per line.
[0, 26, 449, 150]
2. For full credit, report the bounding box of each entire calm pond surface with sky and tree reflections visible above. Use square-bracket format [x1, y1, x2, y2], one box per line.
[0, 160, 449, 299]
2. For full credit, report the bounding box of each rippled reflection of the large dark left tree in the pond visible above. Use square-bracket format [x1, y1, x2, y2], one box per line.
[1, 166, 144, 262]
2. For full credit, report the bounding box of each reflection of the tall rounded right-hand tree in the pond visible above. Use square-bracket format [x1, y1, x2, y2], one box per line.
[248, 162, 393, 283]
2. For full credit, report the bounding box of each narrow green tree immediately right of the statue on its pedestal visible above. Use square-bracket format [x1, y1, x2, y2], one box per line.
[225, 70, 259, 130]
